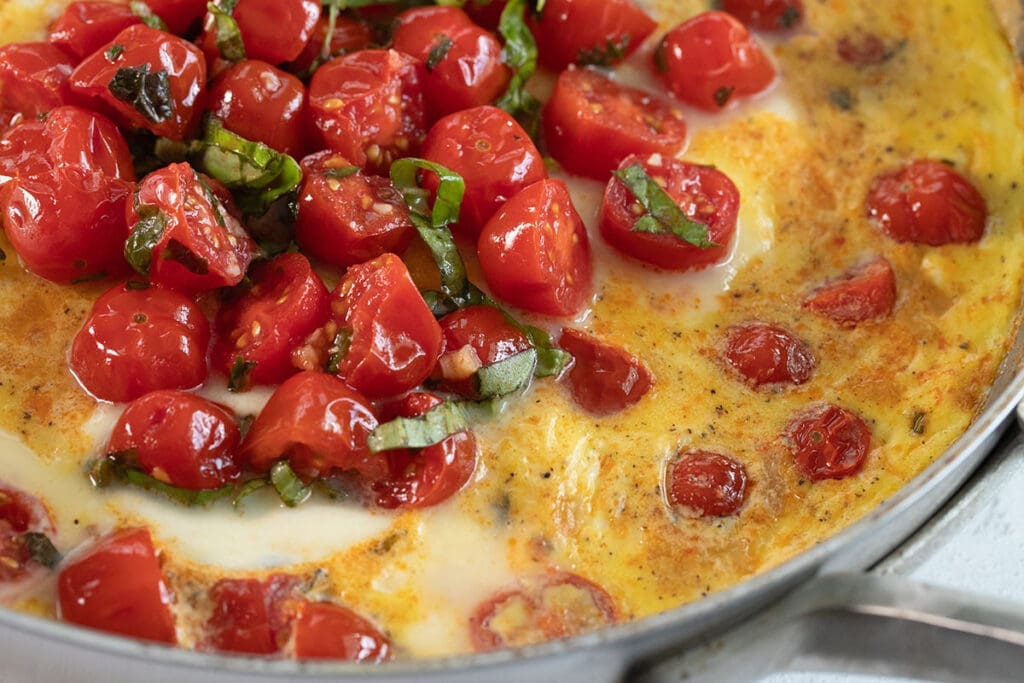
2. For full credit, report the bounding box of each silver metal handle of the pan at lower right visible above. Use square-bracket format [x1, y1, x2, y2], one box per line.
[625, 573, 1024, 683]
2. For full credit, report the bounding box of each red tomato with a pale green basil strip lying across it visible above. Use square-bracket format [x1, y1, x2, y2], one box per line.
[370, 392, 476, 509]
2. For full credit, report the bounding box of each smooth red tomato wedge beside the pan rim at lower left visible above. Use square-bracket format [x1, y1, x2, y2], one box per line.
[57, 528, 177, 644]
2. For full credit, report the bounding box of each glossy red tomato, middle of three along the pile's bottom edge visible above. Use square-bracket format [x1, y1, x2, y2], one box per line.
[241, 371, 386, 479]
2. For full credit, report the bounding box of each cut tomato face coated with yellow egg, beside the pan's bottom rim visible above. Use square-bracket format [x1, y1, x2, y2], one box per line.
[469, 571, 618, 652]
